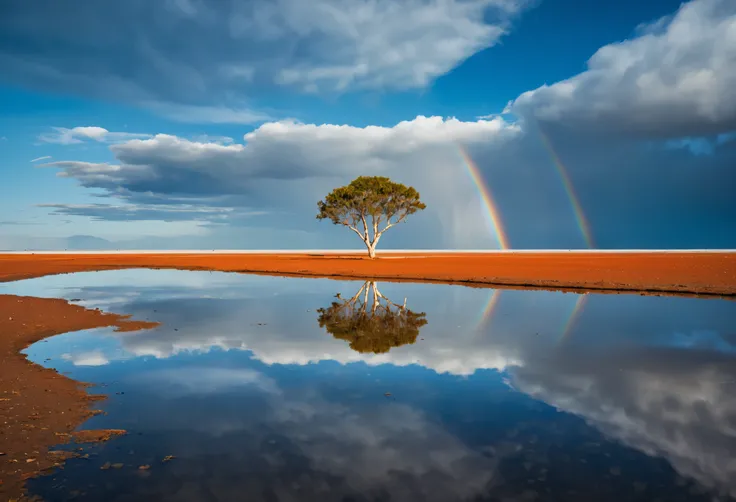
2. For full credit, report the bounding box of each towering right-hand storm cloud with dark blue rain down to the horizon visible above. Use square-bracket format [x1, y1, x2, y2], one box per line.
[481, 0, 736, 248]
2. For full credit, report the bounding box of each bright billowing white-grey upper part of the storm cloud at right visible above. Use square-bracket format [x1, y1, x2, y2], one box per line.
[509, 0, 736, 137]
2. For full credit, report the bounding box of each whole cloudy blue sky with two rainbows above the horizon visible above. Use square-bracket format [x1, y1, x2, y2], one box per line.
[0, 0, 736, 250]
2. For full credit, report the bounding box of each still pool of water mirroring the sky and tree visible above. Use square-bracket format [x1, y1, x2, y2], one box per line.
[0, 270, 736, 502]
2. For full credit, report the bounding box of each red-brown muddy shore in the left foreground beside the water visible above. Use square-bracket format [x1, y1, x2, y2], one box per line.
[0, 295, 156, 500]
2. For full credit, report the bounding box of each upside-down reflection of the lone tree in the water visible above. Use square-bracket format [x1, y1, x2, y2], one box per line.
[317, 281, 427, 354]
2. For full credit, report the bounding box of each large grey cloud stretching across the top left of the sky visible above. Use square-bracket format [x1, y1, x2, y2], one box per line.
[0, 0, 529, 111]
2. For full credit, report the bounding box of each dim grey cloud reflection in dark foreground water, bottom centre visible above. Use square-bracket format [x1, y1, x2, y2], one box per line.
[96, 376, 501, 502]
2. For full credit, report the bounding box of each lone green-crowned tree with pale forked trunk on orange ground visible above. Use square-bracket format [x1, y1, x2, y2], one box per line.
[317, 176, 427, 258]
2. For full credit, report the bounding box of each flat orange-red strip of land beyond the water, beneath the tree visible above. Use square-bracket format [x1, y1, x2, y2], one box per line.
[0, 252, 736, 296]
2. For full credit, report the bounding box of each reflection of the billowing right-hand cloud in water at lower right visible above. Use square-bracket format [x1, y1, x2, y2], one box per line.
[511, 347, 736, 497]
